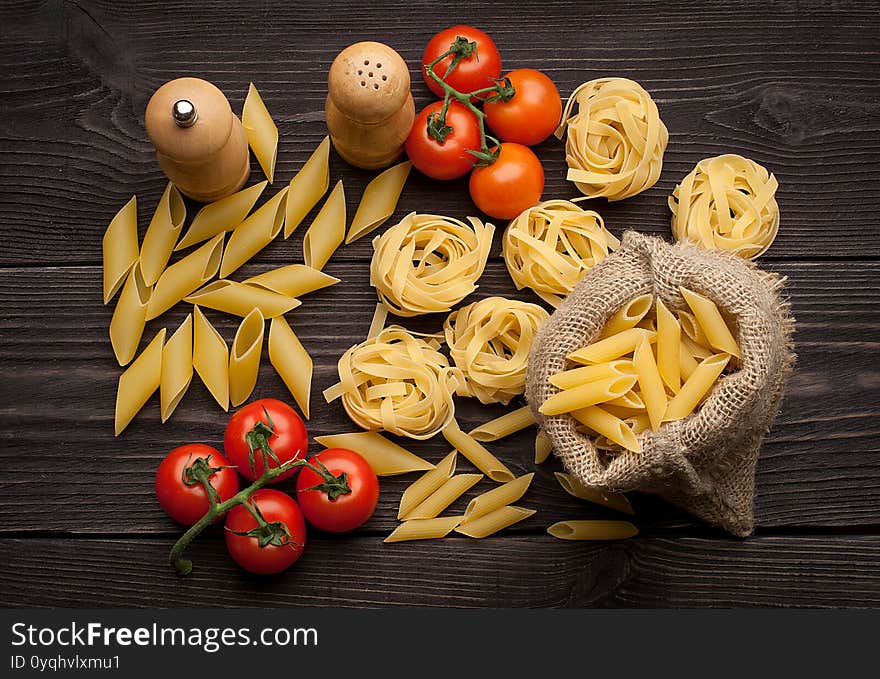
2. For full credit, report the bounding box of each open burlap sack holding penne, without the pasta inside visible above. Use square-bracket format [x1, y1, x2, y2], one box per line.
[526, 231, 795, 536]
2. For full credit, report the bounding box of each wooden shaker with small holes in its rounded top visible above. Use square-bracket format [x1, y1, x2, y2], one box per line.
[325, 42, 415, 169]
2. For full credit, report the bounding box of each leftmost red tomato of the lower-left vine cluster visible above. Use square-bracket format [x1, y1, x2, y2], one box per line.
[155, 443, 238, 526]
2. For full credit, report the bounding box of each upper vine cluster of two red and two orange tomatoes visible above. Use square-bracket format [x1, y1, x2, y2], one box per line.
[406, 25, 562, 219]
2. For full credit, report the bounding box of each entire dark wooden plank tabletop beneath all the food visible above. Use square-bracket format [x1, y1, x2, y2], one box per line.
[0, 0, 880, 607]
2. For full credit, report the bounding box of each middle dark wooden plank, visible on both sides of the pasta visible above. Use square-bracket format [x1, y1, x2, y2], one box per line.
[0, 260, 880, 533]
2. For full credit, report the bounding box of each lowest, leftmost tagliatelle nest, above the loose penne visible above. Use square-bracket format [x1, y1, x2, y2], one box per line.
[324, 325, 460, 440]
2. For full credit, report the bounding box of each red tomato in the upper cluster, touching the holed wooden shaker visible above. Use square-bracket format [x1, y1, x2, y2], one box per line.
[406, 101, 480, 179]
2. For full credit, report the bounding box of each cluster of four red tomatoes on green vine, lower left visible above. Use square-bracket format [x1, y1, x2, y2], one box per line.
[155, 399, 379, 575]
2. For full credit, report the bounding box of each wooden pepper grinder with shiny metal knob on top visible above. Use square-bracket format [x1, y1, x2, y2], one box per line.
[145, 78, 250, 203]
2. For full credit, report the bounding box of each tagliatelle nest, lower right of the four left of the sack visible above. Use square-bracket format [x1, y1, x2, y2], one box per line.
[443, 297, 549, 405]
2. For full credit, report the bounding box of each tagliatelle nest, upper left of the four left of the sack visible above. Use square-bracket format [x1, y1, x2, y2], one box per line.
[370, 212, 495, 316]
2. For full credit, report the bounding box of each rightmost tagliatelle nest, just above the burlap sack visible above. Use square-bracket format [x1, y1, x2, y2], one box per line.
[669, 154, 779, 258]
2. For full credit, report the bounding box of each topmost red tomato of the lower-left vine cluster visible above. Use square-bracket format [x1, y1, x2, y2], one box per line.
[223, 398, 309, 483]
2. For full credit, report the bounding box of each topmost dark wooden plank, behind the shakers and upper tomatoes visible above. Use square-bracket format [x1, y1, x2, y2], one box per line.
[0, 0, 880, 266]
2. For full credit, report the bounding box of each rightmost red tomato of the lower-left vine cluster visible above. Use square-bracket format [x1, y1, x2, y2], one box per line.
[296, 448, 379, 533]
